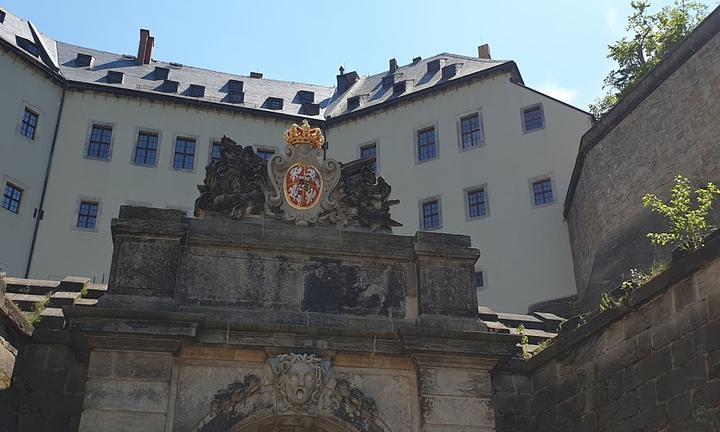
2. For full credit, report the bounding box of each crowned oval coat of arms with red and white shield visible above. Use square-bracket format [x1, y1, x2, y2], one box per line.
[267, 120, 341, 225]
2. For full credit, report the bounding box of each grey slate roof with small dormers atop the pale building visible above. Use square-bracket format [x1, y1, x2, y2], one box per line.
[0, 6, 522, 121]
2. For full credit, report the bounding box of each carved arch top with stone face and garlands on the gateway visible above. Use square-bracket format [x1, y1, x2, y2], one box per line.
[190, 353, 391, 432]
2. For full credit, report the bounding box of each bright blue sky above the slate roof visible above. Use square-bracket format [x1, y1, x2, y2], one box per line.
[1, 0, 704, 108]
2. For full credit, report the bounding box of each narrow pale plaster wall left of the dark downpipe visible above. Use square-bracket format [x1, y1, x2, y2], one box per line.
[0, 52, 62, 277]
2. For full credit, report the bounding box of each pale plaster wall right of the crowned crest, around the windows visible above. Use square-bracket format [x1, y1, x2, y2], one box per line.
[327, 76, 590, 312]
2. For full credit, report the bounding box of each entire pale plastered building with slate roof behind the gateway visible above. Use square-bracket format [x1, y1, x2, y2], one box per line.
[0, 6, 591, 311]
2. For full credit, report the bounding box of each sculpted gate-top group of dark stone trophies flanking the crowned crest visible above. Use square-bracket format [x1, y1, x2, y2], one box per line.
[195, 120, 401, 232]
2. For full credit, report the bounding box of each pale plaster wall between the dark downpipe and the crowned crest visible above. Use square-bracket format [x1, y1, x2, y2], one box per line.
[31, 91, 288, 282]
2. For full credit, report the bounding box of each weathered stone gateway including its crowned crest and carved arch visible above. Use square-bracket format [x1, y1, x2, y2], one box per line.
[60, 123, 518, 432]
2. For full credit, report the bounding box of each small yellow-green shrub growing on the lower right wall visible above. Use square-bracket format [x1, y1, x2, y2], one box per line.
[643, 175, 720, 251]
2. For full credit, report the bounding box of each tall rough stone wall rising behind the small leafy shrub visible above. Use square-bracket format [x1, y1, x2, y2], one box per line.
[565, 10, 720, 309]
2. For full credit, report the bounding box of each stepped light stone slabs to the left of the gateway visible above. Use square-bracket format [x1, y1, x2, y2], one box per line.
[5, 277, 107, 329]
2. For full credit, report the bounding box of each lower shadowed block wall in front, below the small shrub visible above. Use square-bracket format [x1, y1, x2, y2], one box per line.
[493, 231, 720, 432]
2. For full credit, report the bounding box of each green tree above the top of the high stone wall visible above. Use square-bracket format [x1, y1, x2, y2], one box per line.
[590, 0, 707, 118]
